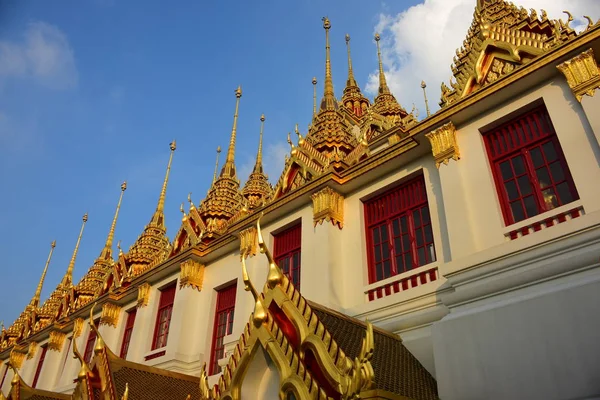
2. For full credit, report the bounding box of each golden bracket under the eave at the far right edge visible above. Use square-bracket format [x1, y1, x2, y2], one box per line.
[557, 49, 600, 102]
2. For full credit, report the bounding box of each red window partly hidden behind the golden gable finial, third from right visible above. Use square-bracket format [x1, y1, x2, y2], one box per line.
[273, 224, 302, 290]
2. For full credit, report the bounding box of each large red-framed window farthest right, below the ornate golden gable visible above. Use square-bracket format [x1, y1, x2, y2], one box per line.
[484, 107, 579, 225]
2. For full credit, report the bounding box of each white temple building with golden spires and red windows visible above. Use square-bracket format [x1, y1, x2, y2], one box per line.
[0, 0, 600, 400]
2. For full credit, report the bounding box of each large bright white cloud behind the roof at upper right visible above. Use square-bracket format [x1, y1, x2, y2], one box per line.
[366, 0, 600, 118]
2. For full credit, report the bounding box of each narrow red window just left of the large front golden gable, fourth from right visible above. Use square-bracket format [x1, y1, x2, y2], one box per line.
[209, 285, 237, 375]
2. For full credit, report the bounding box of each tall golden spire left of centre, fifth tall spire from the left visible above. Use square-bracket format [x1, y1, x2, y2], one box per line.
[198, 87, 244, 233]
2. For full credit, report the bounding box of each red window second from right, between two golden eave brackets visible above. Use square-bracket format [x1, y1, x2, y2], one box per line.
[365, 176, 436, 283]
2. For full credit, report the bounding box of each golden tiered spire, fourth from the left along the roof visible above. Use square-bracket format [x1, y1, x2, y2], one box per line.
[125, 140, 177, 277]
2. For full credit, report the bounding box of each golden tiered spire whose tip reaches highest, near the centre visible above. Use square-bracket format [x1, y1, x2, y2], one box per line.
[306, 17, 358, 161]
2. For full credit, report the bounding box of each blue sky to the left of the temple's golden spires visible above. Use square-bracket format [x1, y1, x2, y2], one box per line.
[0, 0, 422, 325]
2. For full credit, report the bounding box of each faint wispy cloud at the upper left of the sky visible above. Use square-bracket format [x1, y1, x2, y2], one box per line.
[0, 22, 78, 89]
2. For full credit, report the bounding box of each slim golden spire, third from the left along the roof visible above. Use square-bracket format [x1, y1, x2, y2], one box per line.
[74, 182, 127, 309]
